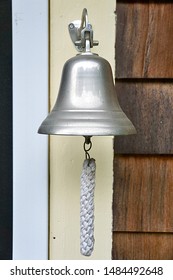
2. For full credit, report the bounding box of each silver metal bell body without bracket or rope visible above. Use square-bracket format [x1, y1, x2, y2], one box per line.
[38, 52, 136, 136]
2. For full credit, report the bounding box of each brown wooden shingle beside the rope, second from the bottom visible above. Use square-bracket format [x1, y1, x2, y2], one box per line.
[113, 156, 173, 232]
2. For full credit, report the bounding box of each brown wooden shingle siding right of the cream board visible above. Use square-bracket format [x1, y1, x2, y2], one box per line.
[112, 1, 173, 260]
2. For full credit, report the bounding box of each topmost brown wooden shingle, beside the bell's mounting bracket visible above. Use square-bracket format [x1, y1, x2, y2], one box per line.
[116, 1, 173, 78]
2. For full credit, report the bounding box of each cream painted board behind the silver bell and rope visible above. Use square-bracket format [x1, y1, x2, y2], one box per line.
[50, 0, 115, 259]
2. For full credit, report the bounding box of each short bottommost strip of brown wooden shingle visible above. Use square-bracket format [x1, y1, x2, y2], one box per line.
[112, 232, 173, 260]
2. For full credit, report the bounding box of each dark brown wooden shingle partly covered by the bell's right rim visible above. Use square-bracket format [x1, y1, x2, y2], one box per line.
[115, 80, 173, 154]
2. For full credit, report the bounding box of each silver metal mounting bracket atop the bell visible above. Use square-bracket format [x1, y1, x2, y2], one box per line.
[68, 8, 99, 52]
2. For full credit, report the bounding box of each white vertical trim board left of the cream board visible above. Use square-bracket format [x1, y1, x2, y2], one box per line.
[12, 0, 48, 260]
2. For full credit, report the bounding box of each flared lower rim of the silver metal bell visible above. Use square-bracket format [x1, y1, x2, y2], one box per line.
[38, 110, 136, 136]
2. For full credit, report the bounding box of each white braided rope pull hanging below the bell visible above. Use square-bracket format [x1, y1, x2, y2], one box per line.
[80, 158, 96, 256]
